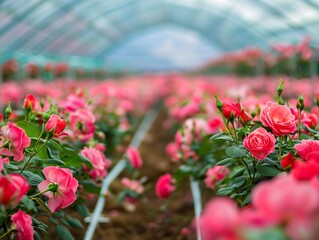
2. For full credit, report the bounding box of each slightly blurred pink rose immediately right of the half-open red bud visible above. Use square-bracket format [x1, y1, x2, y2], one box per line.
[70, 109, 95, 141]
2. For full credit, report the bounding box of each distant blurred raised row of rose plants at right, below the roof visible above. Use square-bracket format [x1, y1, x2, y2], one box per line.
[199, 37, 318, 77]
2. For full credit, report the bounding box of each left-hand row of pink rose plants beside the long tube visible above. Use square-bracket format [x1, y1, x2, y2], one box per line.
[0, 79, 168, 240]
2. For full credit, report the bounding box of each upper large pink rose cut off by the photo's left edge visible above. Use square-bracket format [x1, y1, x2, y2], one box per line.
[0, 122, 31, 162]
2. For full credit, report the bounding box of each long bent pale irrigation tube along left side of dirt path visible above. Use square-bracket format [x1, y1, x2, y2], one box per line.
[84, 105, 160, 240]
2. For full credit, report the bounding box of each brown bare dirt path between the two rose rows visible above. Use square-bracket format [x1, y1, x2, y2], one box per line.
[90, 113, 194, 240]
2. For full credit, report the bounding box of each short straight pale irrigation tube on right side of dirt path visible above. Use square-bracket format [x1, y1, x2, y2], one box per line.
[191, 178, 202, 240]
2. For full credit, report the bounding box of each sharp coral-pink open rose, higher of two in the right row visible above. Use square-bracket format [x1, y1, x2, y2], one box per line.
[260, 101, 297, 136]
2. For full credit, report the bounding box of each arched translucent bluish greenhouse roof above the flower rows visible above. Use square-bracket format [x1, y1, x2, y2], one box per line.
[0, 0, 319, 67]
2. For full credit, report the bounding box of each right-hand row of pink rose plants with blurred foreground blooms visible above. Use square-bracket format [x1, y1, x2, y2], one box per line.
[155, 76, 319, 240]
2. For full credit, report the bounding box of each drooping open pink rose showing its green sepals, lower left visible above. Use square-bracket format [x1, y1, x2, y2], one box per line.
[38, 166, 79, 212]
